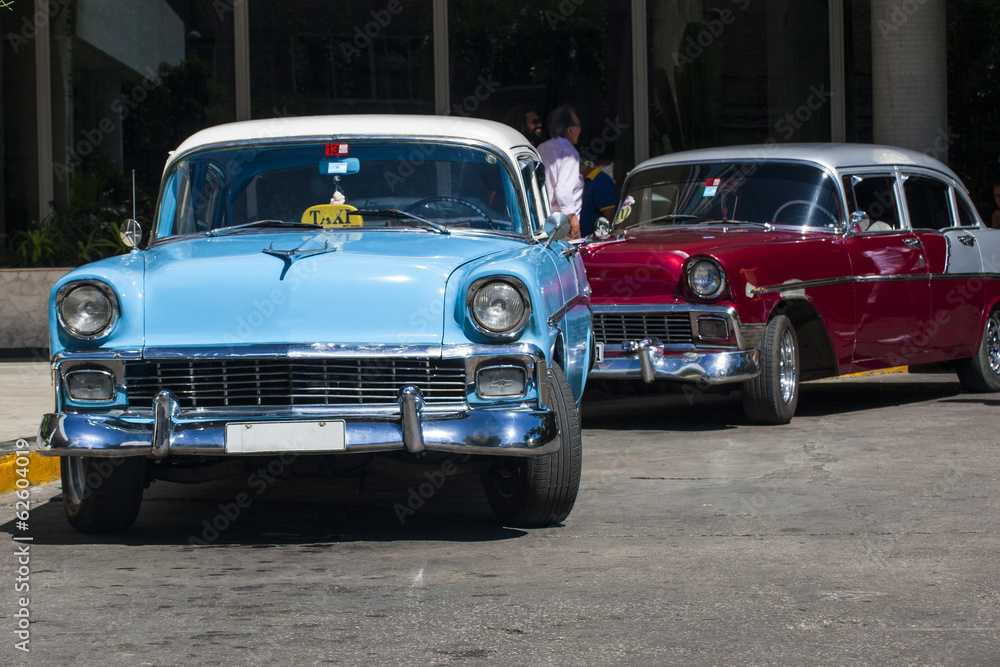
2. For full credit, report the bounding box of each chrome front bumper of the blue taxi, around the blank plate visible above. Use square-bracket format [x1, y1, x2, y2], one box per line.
[37, 392, 559, 458]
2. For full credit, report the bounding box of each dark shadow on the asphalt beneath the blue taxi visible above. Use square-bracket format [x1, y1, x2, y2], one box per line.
[0, 475, 527, 549]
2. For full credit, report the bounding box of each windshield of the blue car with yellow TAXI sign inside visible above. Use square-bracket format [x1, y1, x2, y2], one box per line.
[155, 141, 523, 238]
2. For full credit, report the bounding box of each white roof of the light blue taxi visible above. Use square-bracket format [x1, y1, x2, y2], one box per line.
[167, 114, 534, 167]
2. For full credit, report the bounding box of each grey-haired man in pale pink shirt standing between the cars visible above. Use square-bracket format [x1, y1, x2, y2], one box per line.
[538, 105, 583, 238]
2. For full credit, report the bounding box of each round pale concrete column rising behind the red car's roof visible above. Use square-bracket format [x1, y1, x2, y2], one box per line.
[872, 0, 950, 161]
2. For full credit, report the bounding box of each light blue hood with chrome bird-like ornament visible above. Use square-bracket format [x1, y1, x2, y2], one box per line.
[143, 230, 523, 348]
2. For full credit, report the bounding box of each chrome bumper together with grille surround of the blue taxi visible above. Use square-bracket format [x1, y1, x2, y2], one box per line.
[37, 343, 559, 459]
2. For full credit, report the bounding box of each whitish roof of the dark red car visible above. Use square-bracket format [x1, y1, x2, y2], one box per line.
[633, 143, 961, 183]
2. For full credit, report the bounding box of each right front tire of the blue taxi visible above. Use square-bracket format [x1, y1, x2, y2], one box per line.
[483, 365, 583, 528]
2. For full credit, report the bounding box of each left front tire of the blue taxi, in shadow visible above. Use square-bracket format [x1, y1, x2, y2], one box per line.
[59, 456, 146, 534]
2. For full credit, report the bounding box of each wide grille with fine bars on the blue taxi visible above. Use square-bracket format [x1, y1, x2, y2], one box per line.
[125, 358, 466, 408]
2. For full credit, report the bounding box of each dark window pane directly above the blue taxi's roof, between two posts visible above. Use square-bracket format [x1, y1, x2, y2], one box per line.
[249, 0, 434, 118]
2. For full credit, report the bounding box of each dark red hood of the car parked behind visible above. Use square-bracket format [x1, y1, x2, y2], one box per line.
[583, 224, 820, 303]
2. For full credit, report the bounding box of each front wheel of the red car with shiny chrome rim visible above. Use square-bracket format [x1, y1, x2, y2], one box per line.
[743, 315, 799, 425]
